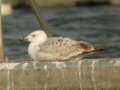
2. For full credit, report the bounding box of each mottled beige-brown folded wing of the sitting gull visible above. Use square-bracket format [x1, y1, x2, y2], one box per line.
[38, 37, 94, 60]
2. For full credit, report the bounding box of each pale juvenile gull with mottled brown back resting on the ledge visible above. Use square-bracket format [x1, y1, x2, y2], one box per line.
[23, 30, 109, 61]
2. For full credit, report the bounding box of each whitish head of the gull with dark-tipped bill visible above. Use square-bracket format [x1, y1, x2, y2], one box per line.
[22, 30, 47, 43]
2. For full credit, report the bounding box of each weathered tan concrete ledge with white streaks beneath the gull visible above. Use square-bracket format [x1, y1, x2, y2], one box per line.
[0, 59, 120, 90]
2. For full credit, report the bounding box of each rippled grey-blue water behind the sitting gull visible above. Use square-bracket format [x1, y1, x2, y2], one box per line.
[3, 6, 120, 59]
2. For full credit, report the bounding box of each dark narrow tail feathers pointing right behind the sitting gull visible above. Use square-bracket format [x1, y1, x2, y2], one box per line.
[82, 47, 112, 56]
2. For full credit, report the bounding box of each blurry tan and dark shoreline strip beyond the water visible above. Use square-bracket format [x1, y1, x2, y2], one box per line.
[8, 0, 120, 8]
